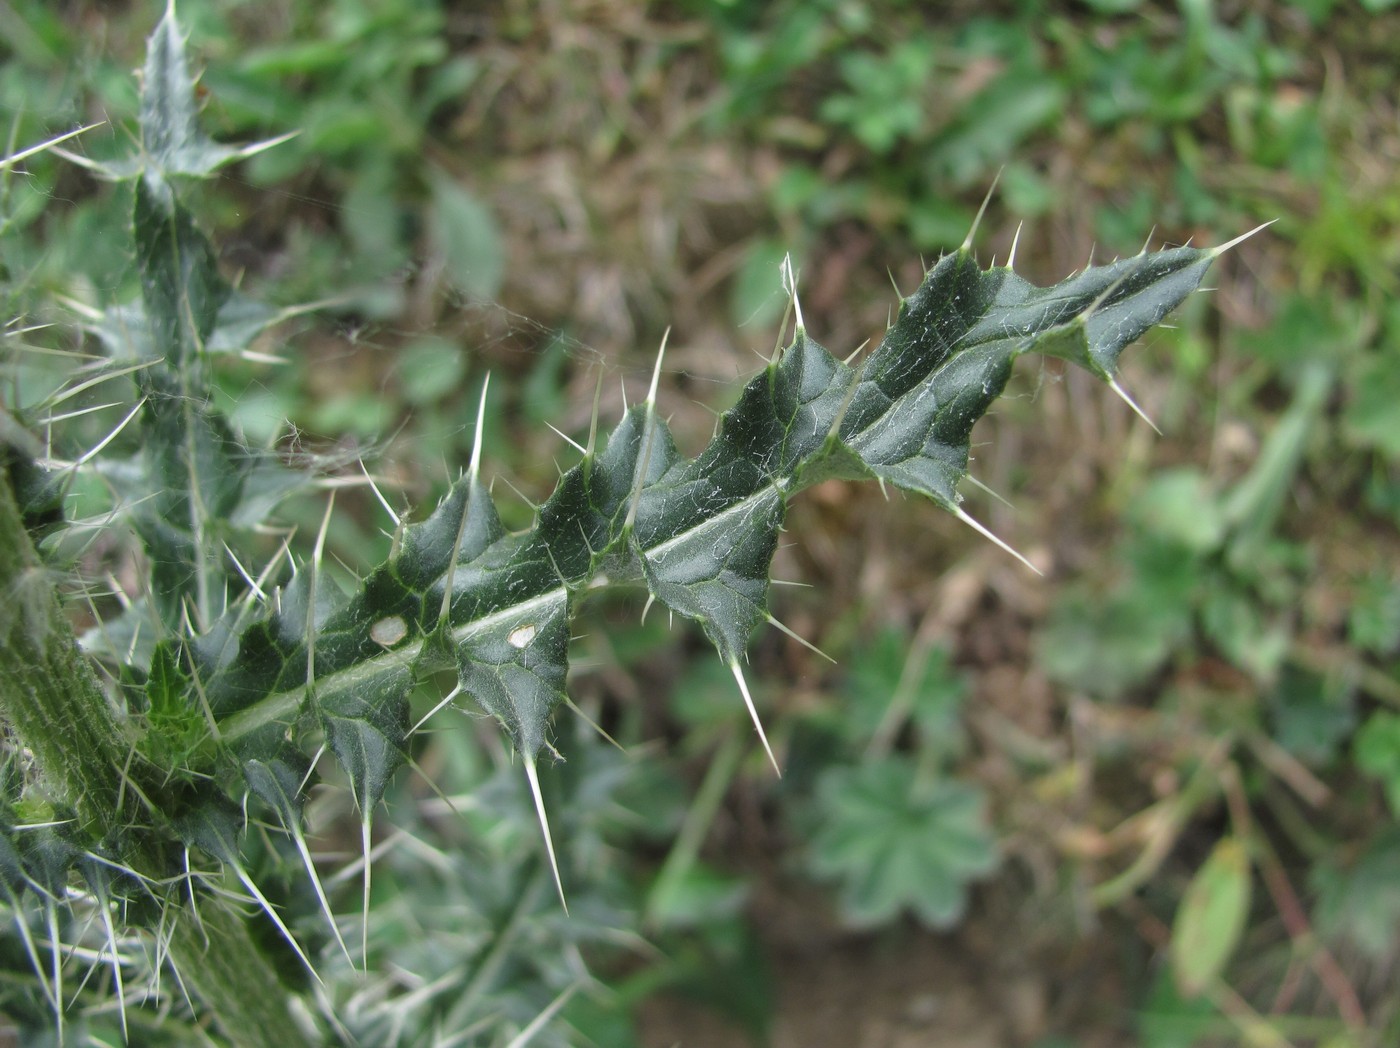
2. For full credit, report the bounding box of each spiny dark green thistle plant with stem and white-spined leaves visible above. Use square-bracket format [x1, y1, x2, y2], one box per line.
[0, 6, 1260, 1044]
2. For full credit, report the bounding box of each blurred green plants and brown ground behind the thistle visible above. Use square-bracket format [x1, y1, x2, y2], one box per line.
[0, 0, 1400, 1048]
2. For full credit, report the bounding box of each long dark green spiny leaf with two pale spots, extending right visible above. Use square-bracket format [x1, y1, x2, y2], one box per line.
[194, 236, 1218, 856]
